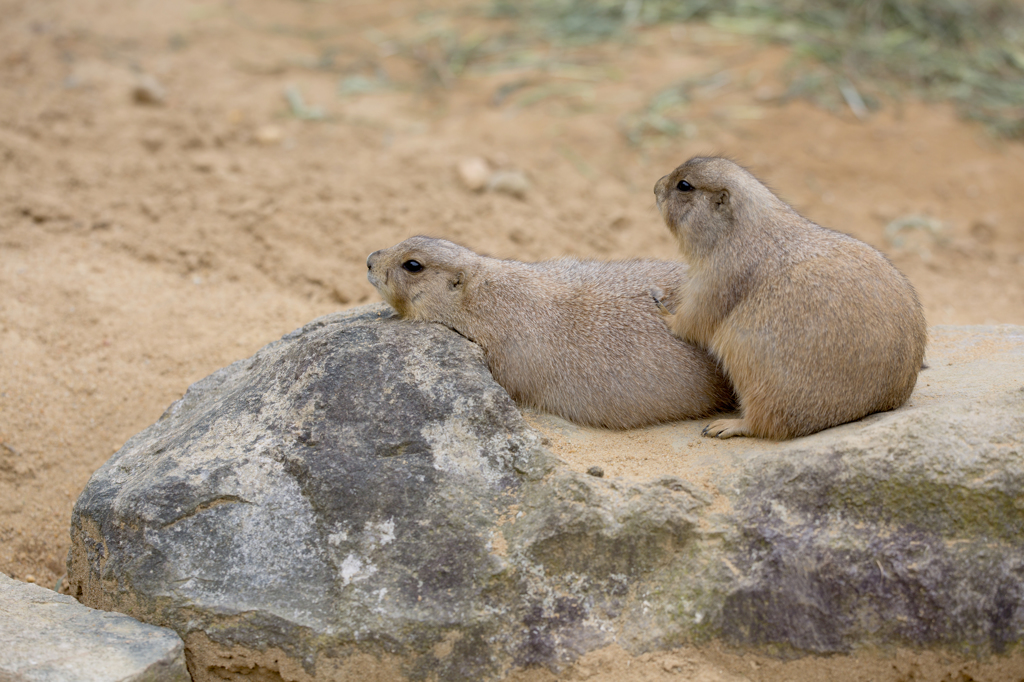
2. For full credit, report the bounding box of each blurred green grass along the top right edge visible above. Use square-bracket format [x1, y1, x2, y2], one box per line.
[490, 0, 1024, 137]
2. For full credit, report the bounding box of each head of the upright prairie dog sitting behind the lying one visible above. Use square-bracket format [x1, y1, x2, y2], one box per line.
[654, 157, 773, 258]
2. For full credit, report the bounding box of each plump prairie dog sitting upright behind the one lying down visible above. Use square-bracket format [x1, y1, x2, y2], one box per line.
[654, 157, 927, 439]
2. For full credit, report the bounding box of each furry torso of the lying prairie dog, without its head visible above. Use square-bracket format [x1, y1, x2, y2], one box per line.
[475, 258, 732, 428]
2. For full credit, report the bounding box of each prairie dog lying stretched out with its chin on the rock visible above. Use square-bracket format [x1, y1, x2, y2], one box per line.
[367, 237, 733, 429]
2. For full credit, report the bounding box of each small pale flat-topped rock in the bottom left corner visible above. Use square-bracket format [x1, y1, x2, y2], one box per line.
[0, 573, 189, 682]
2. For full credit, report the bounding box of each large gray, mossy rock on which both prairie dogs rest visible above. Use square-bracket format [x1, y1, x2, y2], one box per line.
[69, 305, 1024, 681]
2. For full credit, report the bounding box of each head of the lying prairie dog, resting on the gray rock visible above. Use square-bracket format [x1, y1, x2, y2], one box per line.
[367, 237, 479, 326]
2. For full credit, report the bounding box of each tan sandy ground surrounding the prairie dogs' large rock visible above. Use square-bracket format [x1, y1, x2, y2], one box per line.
[0, 0, 1024, 681]
